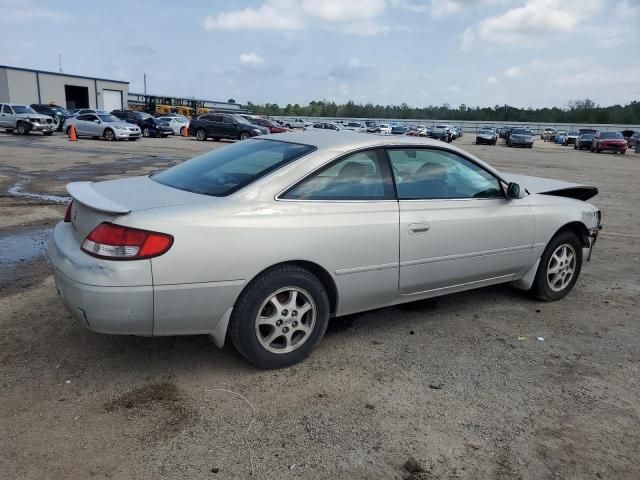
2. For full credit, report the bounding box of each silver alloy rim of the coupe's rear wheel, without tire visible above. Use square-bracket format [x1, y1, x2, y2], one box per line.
[255, 287, 317, 354]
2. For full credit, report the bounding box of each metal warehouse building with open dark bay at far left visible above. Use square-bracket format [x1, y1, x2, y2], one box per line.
[0, 65, 129, 111]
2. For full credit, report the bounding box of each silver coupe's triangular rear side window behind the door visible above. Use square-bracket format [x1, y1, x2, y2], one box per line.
[283, 150, 394, 200]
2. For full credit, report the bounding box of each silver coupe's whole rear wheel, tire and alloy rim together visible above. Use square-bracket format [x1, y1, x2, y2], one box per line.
[229, 265, 329, 368]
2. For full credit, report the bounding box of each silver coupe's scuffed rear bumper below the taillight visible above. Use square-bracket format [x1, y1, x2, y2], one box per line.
[47, 222, 245, 346]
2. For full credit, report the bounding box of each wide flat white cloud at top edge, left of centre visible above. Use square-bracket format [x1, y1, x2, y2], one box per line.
[204, 0, 390, 35]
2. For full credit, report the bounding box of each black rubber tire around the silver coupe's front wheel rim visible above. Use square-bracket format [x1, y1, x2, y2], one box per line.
[531, 230, 582, 302]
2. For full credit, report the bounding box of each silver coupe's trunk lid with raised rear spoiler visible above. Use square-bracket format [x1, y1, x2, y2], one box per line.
[67, 177, 215, 243]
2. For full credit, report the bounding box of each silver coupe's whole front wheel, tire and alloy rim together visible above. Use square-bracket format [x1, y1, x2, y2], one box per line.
[532, 230, 582, 302]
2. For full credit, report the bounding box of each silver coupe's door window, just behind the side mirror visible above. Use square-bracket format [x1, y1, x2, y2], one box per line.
[388, 148, 504, 200]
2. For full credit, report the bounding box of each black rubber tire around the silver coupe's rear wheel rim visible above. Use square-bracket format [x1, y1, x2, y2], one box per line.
[228, 265, 330, 369]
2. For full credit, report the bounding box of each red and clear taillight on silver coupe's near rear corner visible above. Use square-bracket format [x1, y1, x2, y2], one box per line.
[82, 222, 173, 260]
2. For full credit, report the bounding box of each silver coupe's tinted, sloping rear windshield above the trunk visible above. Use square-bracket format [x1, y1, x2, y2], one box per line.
[151, 140, 315, 197]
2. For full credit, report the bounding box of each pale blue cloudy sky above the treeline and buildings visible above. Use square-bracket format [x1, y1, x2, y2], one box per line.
[0, 0, 640, 108]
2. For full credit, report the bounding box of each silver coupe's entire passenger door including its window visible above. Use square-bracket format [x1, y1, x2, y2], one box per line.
[388, 147, 534, 294]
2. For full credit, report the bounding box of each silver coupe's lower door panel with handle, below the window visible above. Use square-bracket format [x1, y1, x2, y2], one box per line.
[400, 199, 534, 294]
